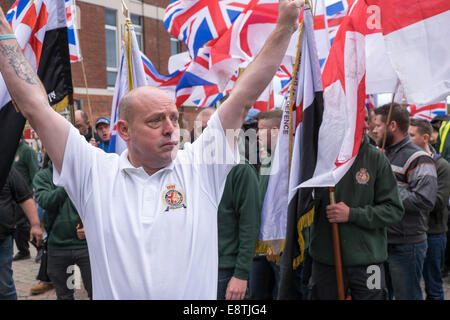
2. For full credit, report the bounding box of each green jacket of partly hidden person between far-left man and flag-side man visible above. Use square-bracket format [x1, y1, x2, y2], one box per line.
[13, 140, 39, 189]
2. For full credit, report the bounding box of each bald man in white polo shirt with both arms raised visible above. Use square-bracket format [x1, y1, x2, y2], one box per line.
[0, 0, 303, 299]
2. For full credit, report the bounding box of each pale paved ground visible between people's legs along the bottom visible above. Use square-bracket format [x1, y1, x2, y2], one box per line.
[13, 247, 450, 300]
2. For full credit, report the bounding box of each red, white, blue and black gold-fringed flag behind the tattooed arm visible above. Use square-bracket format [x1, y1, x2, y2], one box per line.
[0, 0, 73, 187]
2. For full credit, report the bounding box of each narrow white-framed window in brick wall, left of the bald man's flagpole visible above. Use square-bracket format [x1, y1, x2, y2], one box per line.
[105, 9, 118, 87]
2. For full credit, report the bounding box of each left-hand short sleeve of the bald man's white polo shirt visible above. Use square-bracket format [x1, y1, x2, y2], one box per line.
[53, 126, 99, 214]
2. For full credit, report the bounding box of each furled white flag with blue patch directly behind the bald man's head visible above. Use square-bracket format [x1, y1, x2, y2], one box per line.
[108, 26, 147, 154]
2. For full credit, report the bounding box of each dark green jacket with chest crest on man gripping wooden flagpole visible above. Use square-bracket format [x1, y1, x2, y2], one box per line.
[310, 139, 404, 266]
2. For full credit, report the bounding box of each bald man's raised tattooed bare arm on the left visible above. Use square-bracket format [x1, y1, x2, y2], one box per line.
[0, 9, 70, 172]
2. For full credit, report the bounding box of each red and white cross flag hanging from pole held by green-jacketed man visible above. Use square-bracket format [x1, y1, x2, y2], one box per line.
[300, 1, 368, 187]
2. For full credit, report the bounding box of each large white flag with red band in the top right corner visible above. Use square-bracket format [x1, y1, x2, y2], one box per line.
[366, 0, 450, 105]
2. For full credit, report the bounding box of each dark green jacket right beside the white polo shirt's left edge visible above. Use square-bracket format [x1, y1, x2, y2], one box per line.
[33, 162, 87, 250]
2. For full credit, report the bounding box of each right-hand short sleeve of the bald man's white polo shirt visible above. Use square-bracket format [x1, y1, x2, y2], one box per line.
[178, 112, 240, 205]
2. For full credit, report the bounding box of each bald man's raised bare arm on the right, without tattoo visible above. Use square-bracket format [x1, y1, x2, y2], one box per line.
[218, 0, 304, 134]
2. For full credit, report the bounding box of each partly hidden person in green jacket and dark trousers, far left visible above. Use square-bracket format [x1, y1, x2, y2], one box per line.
[13, 136, 39, 261]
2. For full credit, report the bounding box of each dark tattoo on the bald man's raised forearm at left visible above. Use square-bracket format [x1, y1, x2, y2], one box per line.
[0, 45, 40, 85]
